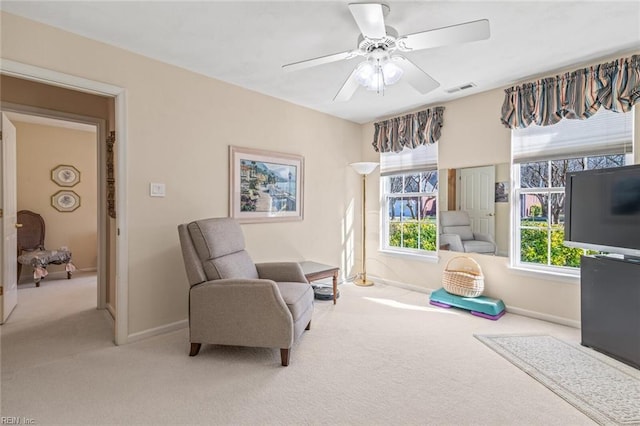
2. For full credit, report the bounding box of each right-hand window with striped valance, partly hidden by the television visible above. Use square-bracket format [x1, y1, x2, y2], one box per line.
[501, 55, 640, 275]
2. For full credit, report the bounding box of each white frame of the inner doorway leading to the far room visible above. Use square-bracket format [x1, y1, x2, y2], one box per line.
[0, 102, 109, 309]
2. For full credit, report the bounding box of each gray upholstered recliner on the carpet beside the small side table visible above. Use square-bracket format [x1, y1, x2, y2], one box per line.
[178, 218, 314, 366]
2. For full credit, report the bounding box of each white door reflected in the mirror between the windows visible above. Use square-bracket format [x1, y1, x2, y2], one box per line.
[459, 166, 496, 237]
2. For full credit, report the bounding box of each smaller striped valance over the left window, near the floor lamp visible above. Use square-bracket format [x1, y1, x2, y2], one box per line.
[372, 107, 444, 152]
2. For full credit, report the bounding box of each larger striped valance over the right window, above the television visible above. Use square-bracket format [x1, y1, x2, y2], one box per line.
[501, 55, 640, 129]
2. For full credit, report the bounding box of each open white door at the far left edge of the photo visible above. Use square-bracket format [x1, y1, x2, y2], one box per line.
[0, 112, 18, 324]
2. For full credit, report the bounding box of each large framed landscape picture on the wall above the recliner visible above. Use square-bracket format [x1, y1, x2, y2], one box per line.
[229, 146, 304, 223]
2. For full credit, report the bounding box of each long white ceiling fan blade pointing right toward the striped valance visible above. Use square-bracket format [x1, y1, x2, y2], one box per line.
[398, 19, 491, 52]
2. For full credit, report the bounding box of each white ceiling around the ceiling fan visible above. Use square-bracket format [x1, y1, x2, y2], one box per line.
[0, 0, 640, 123]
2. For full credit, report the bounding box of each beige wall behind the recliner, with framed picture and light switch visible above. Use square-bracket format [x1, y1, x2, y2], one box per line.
[1, 13, 362, 334]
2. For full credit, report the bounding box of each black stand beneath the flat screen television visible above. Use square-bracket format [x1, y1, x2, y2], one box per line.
[580, 256, 640, 369]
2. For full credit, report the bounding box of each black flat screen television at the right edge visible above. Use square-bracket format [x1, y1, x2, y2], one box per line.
[564, 165, 640, 257]
